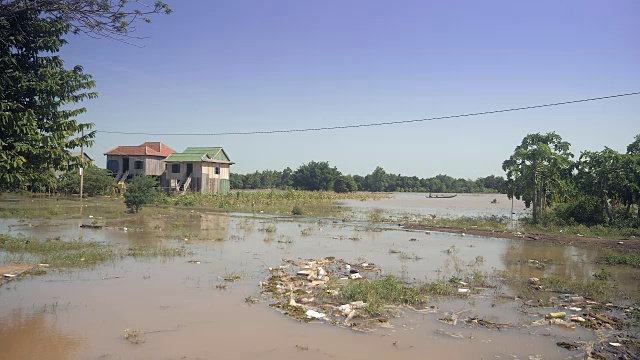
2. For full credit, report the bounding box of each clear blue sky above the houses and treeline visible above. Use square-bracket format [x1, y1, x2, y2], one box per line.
[62, 0, 640, 178]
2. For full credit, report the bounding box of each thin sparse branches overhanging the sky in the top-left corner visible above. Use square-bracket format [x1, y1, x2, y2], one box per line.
[0, 0, 171, 41]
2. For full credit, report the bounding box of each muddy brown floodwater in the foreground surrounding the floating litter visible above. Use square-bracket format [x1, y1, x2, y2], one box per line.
[0, 198, 640, 359]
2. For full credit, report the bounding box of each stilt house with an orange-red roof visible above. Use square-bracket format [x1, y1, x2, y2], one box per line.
[104, 141, 175, 181]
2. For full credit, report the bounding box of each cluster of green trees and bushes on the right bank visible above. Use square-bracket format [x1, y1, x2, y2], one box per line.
[502, 133, 640, 231]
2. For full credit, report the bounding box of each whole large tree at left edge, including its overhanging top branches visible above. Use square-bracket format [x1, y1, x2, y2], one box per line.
[0, 0, 171, 191]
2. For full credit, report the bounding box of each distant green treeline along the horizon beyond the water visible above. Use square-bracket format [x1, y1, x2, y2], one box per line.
[231, 165, 505, 193]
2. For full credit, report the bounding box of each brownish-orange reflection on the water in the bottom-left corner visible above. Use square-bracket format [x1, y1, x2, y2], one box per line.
[0, 309, 84, 359]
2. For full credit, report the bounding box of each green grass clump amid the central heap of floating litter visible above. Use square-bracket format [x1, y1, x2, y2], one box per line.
[341, 276, 454, 315]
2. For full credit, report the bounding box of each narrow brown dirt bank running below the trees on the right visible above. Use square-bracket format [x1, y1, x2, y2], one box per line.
[404, 224, 640, 251]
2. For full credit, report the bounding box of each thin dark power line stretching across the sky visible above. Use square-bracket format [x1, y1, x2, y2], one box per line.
[97, 91, 640, 136]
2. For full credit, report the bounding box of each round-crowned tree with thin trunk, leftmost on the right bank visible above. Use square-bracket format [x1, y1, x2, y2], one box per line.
[502, 132, 573, 223]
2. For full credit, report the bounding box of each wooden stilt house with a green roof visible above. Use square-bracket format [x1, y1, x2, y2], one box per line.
[162, 147, 234, 194]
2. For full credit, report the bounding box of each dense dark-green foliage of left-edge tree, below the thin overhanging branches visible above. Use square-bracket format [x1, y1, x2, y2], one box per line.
[0, 11, 97, 188]
